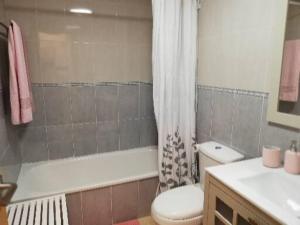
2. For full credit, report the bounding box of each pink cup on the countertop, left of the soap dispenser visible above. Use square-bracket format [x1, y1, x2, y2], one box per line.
[262, 146, 281, 168]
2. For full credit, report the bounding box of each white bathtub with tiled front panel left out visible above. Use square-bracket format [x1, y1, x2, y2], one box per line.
[12, 147, 158, 202]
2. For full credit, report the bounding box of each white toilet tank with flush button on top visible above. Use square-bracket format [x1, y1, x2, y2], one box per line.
[197, 141, 244, 188]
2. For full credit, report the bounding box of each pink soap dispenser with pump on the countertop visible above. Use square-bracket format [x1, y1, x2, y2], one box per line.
[284, 141, 300, 174]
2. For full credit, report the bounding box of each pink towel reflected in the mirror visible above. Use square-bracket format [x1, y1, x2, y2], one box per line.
[279, 40, 300, 102]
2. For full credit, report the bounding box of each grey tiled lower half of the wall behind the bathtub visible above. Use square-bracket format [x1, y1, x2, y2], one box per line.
[19, 82, 157, 162]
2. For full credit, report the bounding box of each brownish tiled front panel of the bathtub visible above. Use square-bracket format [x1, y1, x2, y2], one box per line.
[67, 178, 158, 225]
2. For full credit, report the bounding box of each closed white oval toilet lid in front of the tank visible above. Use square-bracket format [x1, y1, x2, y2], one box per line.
[152, 185, 204, 220]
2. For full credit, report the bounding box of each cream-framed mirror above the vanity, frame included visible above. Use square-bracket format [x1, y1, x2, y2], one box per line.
[267, 0, 300, 129]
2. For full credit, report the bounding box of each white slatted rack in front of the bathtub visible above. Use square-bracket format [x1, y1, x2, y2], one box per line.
[7, 195, 69, 225]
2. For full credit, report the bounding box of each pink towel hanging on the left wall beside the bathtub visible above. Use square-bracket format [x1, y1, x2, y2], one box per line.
[8, 21, 33, 125]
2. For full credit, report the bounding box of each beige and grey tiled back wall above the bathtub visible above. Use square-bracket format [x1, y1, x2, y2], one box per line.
[1, 0, 157, 162]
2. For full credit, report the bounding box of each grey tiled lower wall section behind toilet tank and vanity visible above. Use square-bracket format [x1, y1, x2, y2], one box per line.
[197, 85, 300, 158]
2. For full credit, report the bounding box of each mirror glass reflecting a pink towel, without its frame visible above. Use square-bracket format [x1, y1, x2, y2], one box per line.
[278, 0, 300, 115]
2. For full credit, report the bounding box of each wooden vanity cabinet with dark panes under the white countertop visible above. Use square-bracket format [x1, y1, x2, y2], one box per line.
[204, 174, 280, 225]
